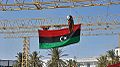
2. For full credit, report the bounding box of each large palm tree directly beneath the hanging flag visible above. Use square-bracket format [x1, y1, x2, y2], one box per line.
[47, 48, 67, 67]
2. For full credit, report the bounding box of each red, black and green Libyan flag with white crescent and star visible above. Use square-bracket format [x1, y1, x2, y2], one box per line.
[38, 24, 81, 49]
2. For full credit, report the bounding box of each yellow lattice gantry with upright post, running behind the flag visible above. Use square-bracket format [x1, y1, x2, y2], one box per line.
[0, 15, 120, 67]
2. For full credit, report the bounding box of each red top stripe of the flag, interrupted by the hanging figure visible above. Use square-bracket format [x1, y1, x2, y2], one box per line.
[38, 24, 81, 37]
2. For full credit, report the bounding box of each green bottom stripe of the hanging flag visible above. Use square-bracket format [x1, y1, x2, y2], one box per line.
[39, 36, 80, 49]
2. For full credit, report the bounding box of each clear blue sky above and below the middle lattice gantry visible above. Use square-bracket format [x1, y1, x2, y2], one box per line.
[0, 1, 120, 59]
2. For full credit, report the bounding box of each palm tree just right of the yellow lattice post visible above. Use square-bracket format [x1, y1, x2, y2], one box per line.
[30, 51, 43, 67]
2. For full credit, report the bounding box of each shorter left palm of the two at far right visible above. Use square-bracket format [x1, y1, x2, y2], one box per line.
[97, 55, 108, 67]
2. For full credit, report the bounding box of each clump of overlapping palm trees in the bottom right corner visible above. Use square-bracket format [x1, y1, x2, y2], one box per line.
[97, 50, 119, 67]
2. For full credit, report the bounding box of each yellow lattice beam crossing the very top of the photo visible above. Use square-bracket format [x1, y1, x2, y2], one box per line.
[0, 0, 120, 11]
